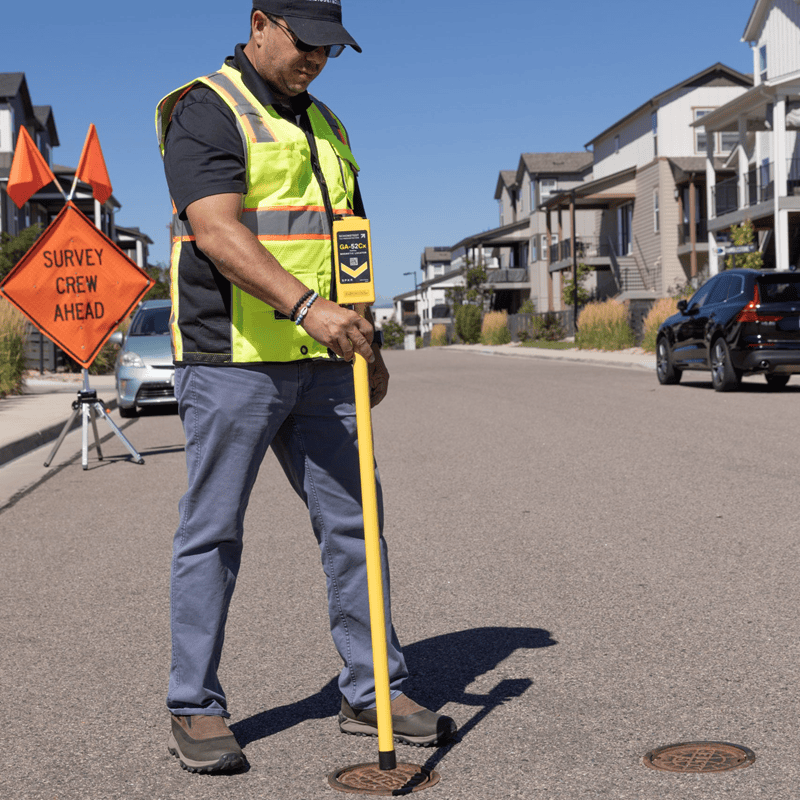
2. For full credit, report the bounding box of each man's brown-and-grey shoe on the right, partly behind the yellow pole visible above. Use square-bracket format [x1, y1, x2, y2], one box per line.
[339, 694, 457, 747]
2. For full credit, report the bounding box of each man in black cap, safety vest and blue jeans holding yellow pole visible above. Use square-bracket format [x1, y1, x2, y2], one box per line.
[157, 0, 455, 772]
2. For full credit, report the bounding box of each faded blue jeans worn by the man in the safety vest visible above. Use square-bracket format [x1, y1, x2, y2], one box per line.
[167, 361, 408, 717]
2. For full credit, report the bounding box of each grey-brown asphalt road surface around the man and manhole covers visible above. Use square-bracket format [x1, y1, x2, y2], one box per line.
[0, 349, 800, 800]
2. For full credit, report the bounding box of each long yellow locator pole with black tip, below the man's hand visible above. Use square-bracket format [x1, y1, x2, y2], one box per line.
[353, 355, 397, 770]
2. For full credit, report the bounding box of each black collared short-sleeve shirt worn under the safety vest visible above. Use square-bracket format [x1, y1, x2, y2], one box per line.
[164, 44, 366, 219]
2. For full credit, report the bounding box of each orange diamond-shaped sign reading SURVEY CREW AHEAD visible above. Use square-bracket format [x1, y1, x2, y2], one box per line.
[0, 203, 155, 367]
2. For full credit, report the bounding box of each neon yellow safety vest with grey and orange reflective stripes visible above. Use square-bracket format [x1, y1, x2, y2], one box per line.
[156, 64, 358, 364]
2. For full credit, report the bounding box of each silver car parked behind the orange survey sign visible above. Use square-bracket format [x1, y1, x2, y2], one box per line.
[110, 300, 176, 417]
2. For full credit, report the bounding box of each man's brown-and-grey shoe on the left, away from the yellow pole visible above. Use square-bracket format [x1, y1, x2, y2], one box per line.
[169, 714, 244, 772]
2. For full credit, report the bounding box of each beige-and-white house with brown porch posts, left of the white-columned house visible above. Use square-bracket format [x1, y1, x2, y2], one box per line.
[540, 63, 752, 310]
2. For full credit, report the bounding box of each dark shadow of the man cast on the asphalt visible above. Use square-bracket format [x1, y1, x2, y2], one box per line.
[231, 627, 557, 768]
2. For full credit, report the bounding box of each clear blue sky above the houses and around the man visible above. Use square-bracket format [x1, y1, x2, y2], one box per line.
[0, 0, 753, 298]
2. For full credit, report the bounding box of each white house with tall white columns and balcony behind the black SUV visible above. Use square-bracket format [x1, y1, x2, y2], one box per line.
[694, 0, 800, 274]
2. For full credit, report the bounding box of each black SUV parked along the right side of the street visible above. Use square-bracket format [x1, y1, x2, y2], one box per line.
[656, 269, 800, 392]
